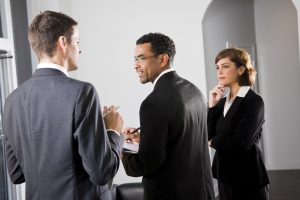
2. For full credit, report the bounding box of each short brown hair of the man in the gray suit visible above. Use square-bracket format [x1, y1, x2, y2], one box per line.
[28, 11, 77, 57]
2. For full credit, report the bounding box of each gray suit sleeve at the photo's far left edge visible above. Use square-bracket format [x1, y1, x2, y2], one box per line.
[5, 136, 25, 184]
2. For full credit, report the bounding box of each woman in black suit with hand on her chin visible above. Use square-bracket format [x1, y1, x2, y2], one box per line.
[208, 48, 269, 200]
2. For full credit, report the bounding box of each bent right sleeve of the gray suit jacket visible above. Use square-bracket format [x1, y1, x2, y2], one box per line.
[74, 85, 123, 185]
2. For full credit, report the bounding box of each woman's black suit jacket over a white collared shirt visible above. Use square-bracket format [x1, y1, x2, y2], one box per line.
[208, 89, 269, 187]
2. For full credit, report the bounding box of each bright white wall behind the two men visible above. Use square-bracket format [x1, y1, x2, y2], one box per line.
[27, 0, 208, 184]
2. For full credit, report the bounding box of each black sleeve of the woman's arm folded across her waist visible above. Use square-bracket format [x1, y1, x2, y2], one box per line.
[212, 97, 264, 151]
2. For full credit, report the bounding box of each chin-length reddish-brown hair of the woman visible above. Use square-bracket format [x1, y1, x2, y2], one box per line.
[215, 48, 256, 86]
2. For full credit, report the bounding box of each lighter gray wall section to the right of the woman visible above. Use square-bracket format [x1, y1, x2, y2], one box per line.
[254, 0, 300, 169]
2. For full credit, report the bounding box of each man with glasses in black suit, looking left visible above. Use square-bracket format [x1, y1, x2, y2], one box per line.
[122, 33, 214, 200]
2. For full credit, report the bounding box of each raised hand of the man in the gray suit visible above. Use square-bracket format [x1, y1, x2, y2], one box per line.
[102, 105, 124, 133]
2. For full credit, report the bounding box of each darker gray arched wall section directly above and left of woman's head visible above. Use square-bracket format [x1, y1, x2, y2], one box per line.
[202, 0, 255, 94]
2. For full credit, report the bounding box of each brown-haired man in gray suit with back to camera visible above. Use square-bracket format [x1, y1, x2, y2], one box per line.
[4, 11, 124, 200]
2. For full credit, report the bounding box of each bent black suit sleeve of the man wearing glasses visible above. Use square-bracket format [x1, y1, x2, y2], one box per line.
[122, 99, 168, 177]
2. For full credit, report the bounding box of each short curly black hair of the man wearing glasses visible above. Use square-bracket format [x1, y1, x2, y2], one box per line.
[136, 33, 176, 64]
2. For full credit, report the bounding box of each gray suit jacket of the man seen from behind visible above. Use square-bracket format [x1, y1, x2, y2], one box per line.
[3, 69, 123, 200]
